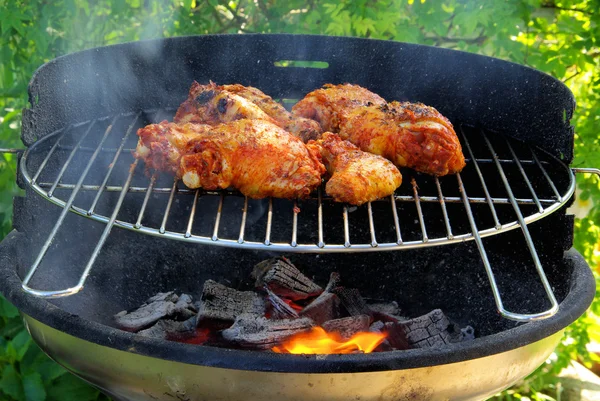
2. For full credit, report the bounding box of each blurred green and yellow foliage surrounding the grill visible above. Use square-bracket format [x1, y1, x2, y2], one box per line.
[0, 0, 600, 401]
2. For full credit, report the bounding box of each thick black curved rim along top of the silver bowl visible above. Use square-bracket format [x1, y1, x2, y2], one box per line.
[0, 230, 596, 373]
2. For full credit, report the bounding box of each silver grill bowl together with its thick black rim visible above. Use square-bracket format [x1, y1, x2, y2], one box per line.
[0, 228, 595, 400]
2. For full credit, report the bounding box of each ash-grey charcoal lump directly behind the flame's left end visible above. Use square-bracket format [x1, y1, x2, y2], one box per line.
[221, 314, 314, 349]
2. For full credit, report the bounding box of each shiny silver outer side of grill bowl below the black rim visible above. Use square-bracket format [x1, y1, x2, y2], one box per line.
[24, 316, 562, 401]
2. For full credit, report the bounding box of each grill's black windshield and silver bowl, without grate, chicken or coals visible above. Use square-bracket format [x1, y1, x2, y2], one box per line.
[0, 35, 594, 400]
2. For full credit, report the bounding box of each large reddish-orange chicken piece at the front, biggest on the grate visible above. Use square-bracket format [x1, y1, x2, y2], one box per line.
[180, 119, 325, 199]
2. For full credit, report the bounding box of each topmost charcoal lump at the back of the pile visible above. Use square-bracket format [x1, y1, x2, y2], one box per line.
[252, 257, 323, 301]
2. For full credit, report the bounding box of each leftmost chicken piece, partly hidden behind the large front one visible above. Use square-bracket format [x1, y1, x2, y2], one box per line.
[134, 120, 212, 174]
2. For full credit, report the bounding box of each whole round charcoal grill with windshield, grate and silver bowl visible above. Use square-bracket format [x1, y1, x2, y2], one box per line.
[0, 35, 598, 400]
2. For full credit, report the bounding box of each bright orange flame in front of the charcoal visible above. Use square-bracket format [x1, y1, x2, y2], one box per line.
[272, 327, 386, 354]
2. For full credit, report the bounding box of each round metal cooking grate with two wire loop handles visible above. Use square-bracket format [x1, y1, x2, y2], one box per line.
[20, 109, 575, 321]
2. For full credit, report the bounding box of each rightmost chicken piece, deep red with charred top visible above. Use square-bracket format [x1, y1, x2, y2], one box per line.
[340, 102, 465, 176]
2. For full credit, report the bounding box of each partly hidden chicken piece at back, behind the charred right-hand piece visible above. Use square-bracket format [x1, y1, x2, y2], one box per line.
[292, 84, 386, 132]
